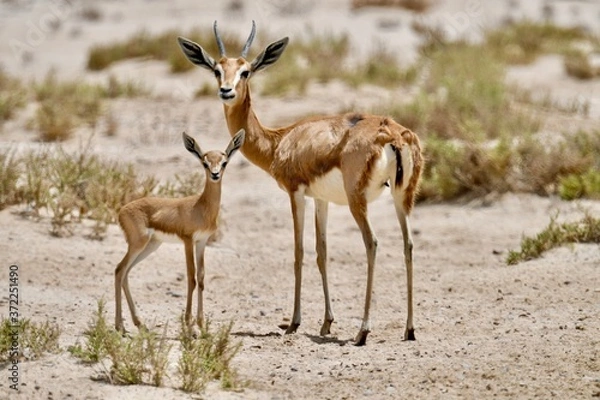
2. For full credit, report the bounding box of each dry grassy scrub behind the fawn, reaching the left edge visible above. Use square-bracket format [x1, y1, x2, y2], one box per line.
[0, 141, 204, 239]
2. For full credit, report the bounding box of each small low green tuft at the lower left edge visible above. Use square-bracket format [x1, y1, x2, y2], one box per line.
[0, 317, 60, 362]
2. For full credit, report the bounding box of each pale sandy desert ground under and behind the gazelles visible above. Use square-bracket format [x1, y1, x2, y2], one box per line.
[0, 0, 600, 399]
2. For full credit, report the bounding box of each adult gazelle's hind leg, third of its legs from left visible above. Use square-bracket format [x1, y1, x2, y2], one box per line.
[349, 194, 377, 346]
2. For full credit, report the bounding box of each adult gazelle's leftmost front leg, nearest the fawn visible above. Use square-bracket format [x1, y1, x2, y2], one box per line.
[285, 190, 305, 334]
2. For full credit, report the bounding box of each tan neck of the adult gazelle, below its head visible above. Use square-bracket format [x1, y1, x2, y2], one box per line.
[223, 88, 282, 173]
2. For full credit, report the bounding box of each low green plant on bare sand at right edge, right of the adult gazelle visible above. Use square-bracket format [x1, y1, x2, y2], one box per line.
[506, 212, 600, 265]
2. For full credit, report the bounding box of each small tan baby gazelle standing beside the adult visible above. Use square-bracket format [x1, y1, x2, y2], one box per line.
[115, 129, 245, 331]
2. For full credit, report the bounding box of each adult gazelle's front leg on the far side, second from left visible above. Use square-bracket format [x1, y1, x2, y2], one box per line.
[315, 199, 334, 336]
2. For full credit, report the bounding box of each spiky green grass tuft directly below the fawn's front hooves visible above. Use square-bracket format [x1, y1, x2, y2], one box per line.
[177, 316, 241, 393]
